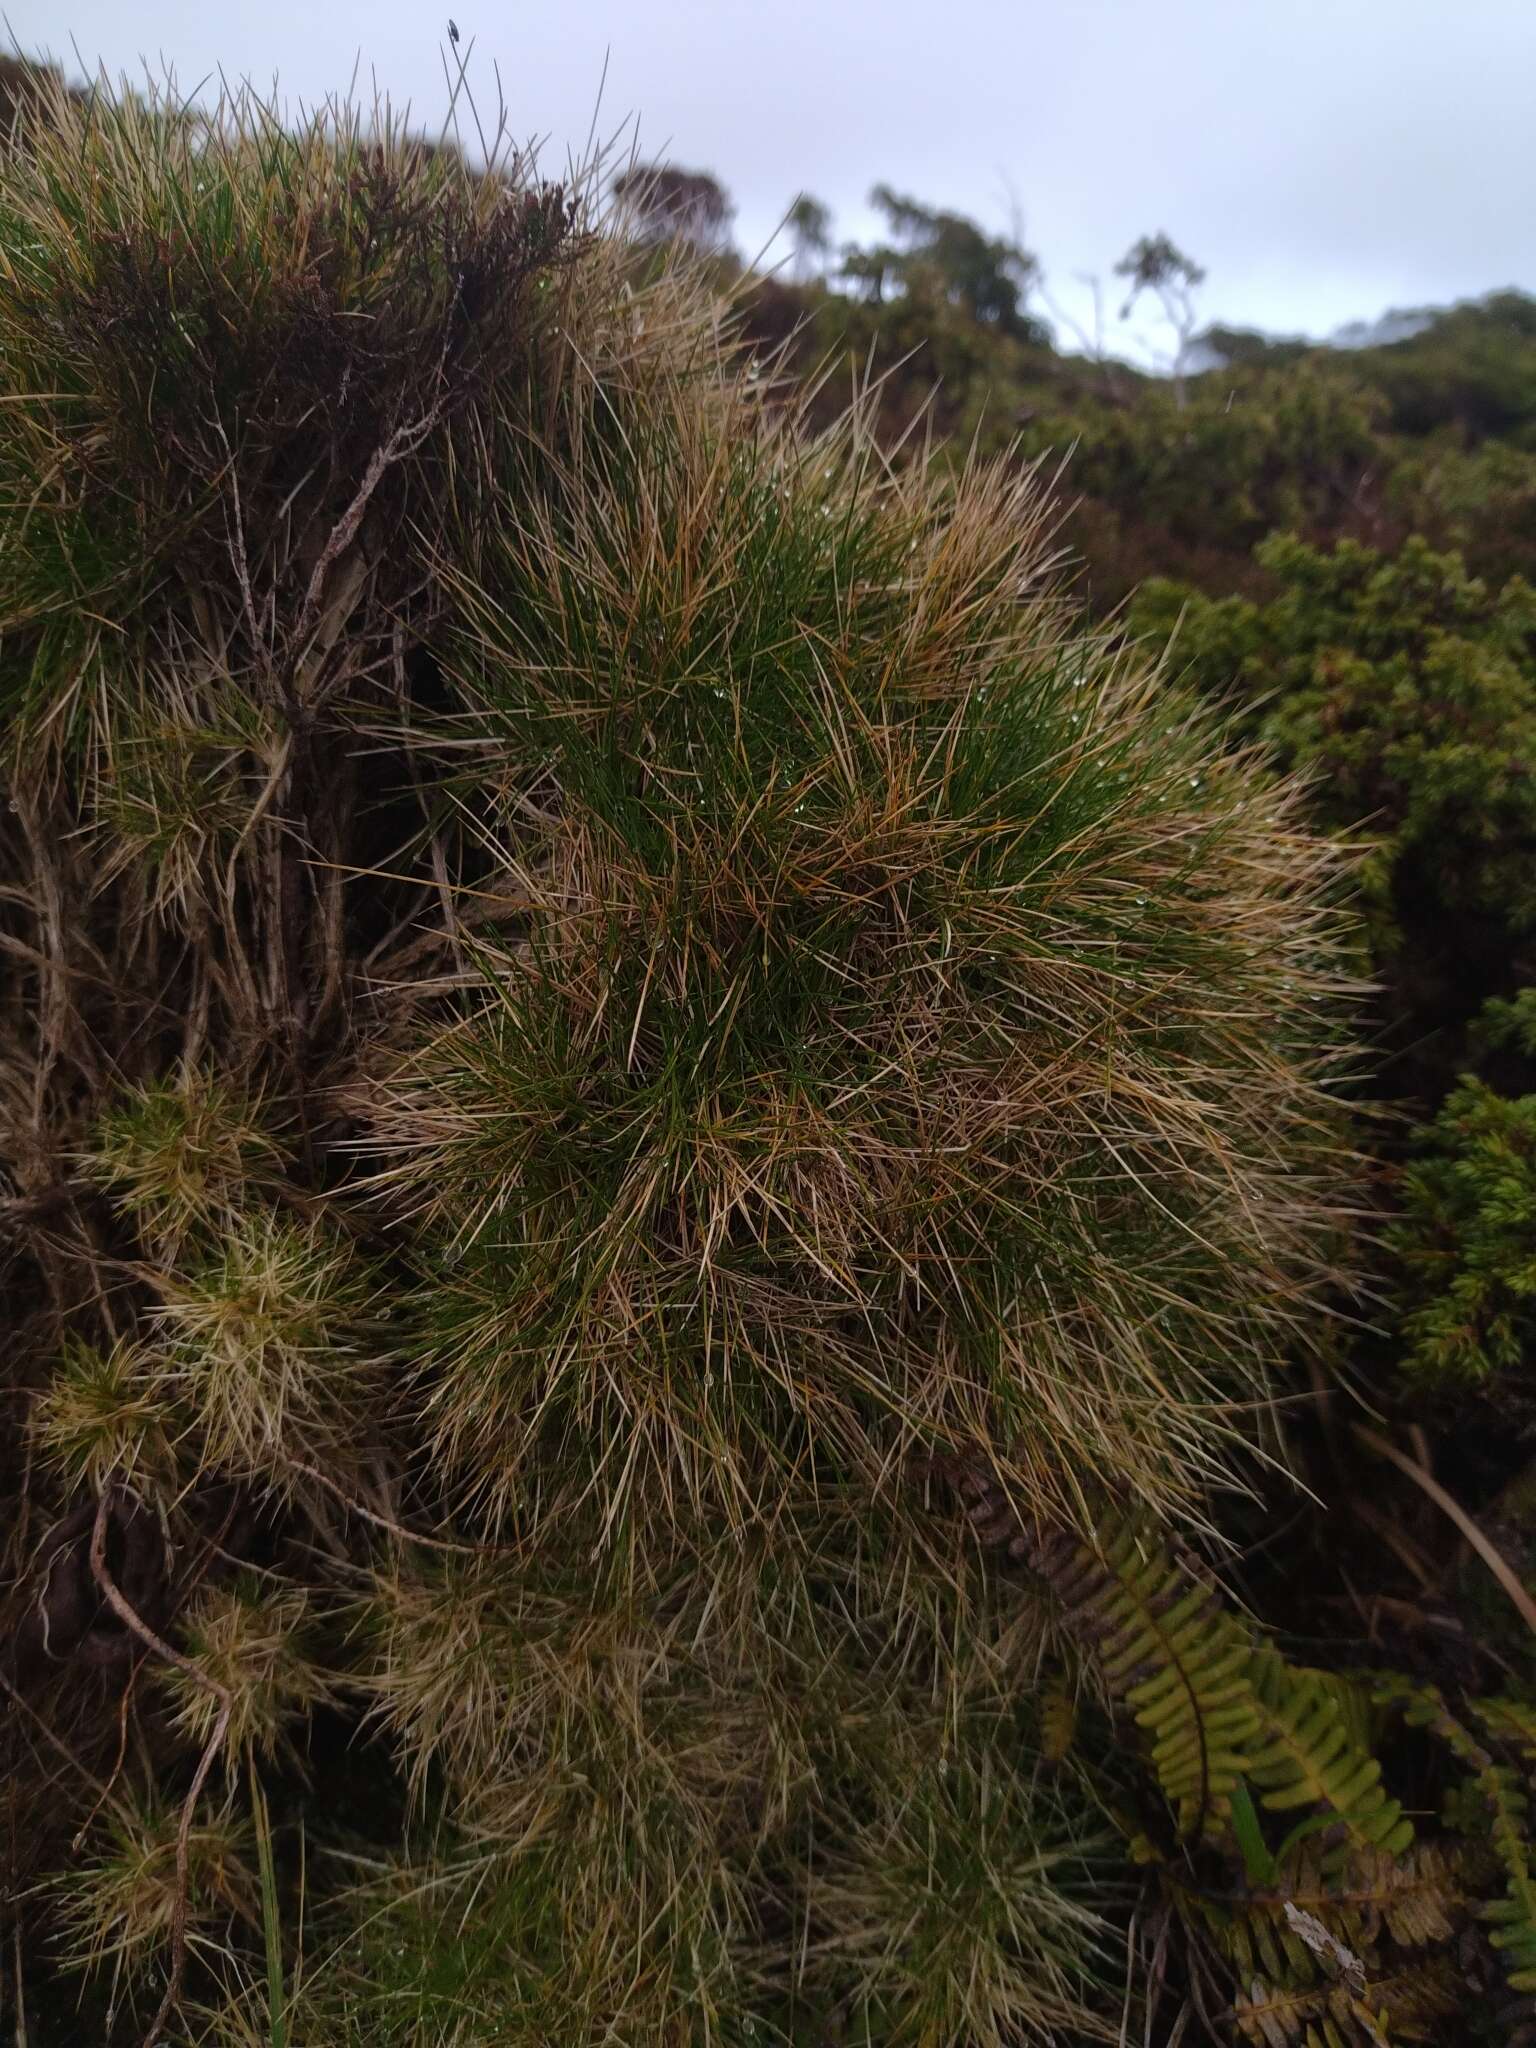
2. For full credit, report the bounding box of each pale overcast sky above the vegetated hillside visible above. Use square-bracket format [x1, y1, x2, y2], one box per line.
[6, 0, 1536, 360]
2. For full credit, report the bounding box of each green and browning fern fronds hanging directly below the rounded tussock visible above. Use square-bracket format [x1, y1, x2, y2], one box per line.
[1022, 1520, 1466, 2048]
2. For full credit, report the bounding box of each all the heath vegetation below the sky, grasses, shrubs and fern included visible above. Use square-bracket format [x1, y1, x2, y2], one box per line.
[0, 48, 1536, 2048]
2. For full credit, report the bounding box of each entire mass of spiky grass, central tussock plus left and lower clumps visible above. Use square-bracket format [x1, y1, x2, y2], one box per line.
[0, 64, 1350, 2048]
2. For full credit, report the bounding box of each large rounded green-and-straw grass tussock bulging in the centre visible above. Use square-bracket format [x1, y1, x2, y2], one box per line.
[362, 377, 1368, 1528]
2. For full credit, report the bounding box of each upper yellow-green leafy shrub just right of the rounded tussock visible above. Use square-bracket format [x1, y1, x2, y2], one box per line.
[1133, 537, 1536, 1096]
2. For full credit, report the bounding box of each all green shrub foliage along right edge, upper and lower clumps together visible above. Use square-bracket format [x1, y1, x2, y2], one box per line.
[1133, 537, 1536, 1421]
